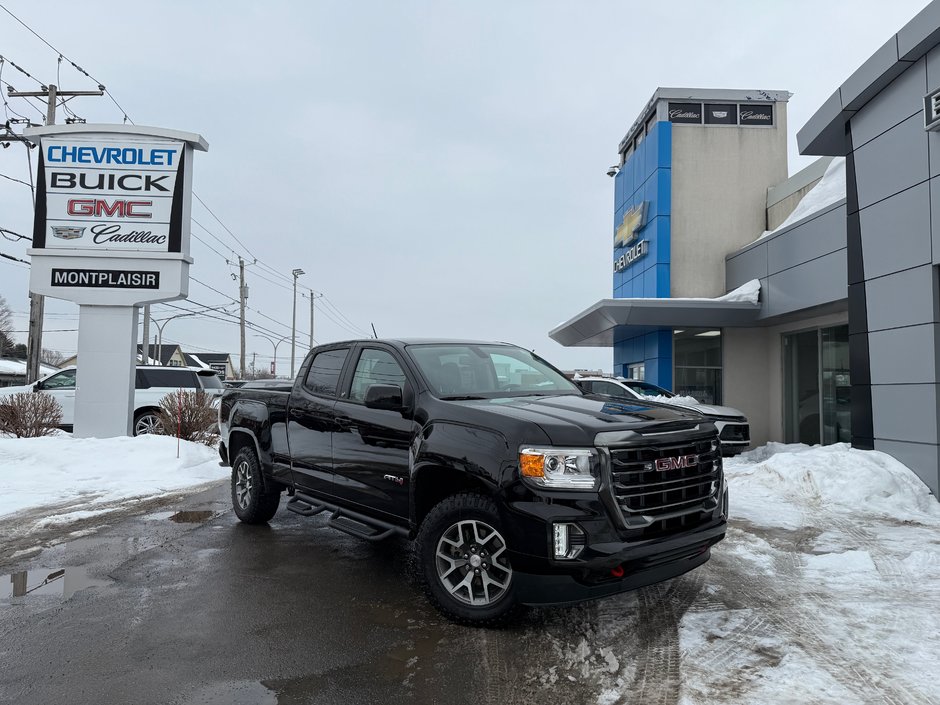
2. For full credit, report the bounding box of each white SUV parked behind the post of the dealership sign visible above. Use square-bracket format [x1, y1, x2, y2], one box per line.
[0, 366, 224, 436]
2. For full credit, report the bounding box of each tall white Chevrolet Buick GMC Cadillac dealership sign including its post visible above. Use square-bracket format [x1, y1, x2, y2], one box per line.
[24, 124, 208, 438]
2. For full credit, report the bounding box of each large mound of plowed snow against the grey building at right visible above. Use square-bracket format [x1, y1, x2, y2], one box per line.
[725, 443, 940, 528]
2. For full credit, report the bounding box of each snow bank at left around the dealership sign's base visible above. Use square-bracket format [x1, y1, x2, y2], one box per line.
[0, 434, 229, 520]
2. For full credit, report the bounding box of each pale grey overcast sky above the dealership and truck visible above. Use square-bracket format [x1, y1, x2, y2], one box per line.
[0, 0, 927, 372]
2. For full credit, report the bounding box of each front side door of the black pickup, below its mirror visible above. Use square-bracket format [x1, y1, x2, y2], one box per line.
[333, 345, 418, 518]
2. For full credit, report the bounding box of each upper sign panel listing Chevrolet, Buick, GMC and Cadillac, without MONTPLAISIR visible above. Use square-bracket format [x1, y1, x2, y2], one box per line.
[33, 137, 185, 252]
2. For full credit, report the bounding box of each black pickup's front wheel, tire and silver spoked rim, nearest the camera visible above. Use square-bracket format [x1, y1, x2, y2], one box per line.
[415, 493, 516, 626]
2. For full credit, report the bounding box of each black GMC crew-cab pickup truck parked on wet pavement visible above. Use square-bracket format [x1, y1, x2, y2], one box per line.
[219, 340, 728, 624]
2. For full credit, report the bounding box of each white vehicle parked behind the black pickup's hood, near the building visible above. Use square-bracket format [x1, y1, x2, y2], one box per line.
[574, 377, 751, 455]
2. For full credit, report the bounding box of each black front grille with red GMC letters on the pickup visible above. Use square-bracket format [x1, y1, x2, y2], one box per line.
[610, 438, 722, 536]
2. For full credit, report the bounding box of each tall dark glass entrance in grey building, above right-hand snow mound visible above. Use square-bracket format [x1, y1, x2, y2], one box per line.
[783, 326, 852, 445]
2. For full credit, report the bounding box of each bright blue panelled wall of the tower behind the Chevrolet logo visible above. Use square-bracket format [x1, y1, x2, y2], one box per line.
[612, 122, 672, 389]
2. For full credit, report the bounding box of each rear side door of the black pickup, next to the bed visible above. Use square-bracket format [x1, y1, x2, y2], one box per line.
[287, 348, 349, 495]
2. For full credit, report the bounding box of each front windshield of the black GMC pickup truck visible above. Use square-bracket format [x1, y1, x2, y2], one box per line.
[407, 344, 581, 399]
